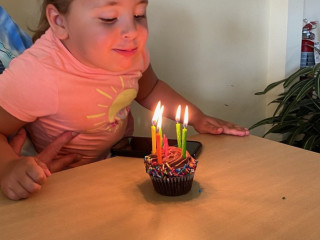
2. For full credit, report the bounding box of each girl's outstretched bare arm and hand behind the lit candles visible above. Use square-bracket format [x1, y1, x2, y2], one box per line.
[136, 65, 249, 136]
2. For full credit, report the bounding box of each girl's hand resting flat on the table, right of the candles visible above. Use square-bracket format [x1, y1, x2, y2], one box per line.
[193, 115, 250, 136]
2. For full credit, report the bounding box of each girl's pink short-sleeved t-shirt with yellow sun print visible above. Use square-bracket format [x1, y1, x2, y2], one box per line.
[0, 29, 149, 162]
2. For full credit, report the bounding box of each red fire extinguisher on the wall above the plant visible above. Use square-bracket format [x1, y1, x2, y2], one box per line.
[300, 19, 317, 67]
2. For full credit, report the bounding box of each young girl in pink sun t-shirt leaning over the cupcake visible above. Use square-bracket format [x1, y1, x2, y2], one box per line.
[0, 0, 249, 200]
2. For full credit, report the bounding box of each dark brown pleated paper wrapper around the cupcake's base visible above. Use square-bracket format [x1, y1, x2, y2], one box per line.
[150, 174, 194, 196]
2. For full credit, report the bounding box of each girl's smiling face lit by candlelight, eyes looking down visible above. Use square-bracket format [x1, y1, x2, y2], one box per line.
[63, 0, 148, 71]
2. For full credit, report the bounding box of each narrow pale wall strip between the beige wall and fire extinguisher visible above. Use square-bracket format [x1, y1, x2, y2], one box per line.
[260, 0, 304, 140]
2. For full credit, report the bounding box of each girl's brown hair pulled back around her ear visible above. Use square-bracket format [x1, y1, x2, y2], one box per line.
[32, 0, 72, 42]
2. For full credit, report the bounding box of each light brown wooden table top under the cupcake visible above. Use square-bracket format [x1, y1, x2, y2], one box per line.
[0, 135, 320, 240]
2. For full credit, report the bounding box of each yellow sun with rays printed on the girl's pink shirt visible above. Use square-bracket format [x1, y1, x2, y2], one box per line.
[87, 72, 141, 132]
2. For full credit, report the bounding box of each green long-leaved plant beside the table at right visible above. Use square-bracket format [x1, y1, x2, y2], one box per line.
[250, 49, 320, 152]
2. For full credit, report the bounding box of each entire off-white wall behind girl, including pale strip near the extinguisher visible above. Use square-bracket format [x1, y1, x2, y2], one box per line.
[0, 0, 314, 137]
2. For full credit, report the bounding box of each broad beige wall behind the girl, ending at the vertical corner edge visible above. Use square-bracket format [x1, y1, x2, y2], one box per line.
[134, 0, 269, 136]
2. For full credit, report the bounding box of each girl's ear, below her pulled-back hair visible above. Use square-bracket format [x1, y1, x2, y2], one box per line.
[46, 4, 68, 40]
